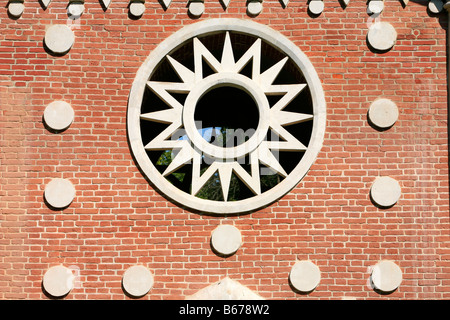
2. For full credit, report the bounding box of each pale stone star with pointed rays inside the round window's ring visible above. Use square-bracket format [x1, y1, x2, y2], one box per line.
[140, 32, 313, 201]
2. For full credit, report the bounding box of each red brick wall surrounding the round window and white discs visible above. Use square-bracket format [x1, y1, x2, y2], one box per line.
[0, 0, 450, 299]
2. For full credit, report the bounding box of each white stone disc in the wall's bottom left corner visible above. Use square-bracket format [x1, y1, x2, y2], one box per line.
[42, 266, 75, 297]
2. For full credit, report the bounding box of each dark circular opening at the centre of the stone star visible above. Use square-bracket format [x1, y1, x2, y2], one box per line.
[194, 86, 259, 148]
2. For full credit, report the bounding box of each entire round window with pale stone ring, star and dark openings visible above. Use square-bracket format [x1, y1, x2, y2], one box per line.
[127, 19, 325, 214]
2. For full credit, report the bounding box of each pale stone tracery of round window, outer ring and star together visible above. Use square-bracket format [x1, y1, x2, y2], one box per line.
[127, 18, 326, 215]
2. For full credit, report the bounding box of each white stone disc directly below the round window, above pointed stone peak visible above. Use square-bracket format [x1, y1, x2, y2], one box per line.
[211, 225, 242, 255]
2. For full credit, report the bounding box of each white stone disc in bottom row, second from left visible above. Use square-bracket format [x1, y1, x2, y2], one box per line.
[122, 266, 154, 297]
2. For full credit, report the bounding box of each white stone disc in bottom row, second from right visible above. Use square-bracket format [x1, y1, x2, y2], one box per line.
[289, 260, 320, 292]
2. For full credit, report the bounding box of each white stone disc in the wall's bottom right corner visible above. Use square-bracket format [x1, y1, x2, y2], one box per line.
[371, 260, 402, 292]
